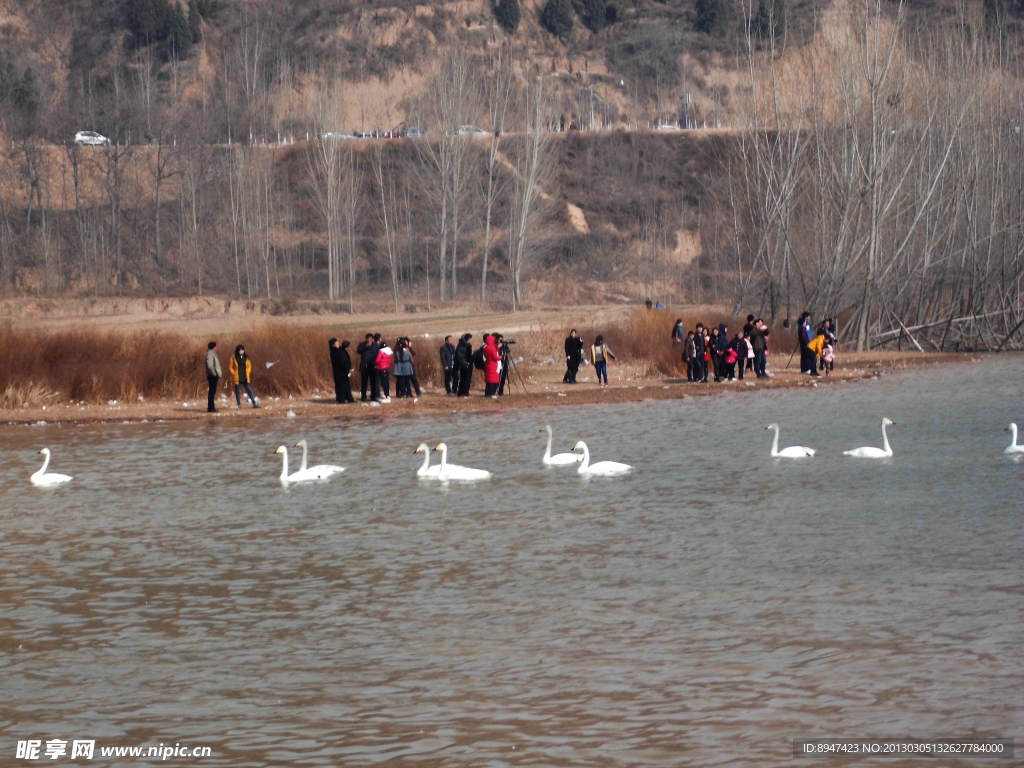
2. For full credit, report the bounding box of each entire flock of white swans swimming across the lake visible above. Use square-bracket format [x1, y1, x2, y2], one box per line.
[30, 419, 1024, 486]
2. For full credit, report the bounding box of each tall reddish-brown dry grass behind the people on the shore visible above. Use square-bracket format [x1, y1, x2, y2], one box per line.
[0, 309, 795, 410]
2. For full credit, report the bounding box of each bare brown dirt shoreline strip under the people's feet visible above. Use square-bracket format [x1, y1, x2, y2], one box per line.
[0, 350, 974, 426]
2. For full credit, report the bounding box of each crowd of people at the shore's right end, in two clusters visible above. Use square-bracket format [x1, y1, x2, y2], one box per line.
[672, 311, 836, 383]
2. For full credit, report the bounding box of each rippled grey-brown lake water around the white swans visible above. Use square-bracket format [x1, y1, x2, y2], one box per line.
[0, 355, 1024, 766]
